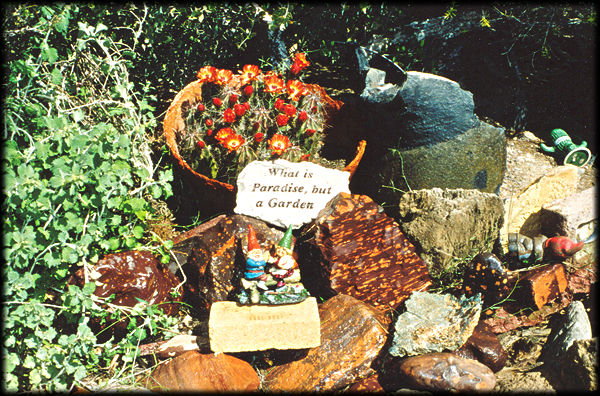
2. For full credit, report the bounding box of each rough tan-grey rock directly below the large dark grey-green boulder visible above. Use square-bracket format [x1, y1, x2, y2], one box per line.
[398, 188, 504, 276]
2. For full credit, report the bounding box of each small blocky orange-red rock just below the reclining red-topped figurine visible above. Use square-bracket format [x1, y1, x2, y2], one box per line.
[517, 263, 568, 309]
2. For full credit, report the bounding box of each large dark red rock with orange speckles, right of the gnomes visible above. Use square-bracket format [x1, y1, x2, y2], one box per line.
[297, 193, 431, 309]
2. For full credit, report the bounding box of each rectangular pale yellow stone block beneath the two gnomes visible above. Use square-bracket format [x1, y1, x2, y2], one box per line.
[208, 297, 321, 353]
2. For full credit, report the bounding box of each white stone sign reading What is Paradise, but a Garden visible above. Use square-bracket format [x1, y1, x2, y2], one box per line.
[234, 159, 350, 228]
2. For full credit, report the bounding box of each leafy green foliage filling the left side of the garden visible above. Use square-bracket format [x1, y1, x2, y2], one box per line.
[2, 5, 172, 391]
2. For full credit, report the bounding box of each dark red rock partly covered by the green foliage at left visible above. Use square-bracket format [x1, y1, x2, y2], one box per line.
[69, 251, 181, 334]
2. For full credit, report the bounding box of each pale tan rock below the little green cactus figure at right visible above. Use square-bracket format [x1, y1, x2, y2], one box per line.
[500, 165, 583, 251]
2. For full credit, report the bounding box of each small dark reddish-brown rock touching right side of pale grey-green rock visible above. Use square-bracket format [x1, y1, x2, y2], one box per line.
[455, 322, 508, 372]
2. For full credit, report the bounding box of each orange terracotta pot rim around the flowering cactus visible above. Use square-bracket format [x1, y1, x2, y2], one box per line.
[163, 80, 367, 213]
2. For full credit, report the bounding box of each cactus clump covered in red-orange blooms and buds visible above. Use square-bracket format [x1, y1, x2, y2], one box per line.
[178, 53, 335, 183]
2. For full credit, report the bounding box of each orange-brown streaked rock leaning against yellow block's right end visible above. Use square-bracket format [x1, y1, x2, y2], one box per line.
[263, 294, 389, 392]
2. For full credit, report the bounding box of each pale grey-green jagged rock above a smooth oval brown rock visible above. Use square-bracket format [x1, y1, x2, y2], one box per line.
[389, 292, 481, 356]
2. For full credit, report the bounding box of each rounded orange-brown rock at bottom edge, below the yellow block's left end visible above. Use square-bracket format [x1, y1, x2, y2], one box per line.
[146, 351, 260, 392]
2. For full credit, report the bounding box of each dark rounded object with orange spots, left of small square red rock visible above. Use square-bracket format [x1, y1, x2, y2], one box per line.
[462, 252, 510, 306]
